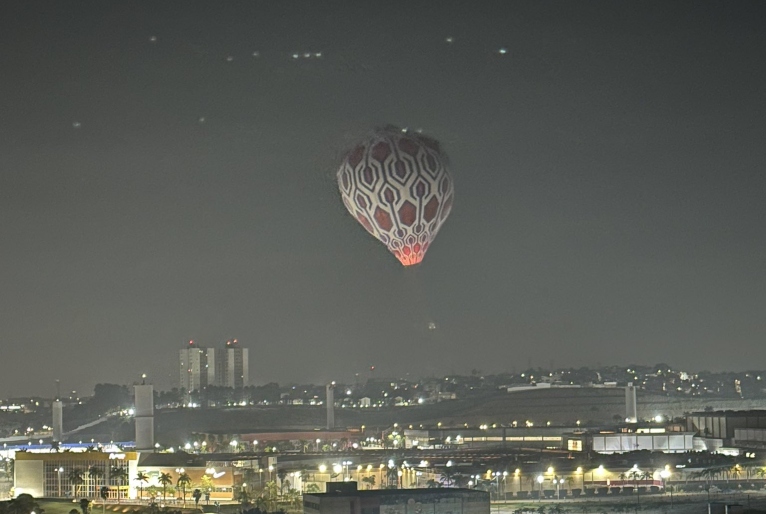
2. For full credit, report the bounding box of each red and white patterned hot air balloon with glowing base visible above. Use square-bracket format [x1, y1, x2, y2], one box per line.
[338, 127, 454, 266]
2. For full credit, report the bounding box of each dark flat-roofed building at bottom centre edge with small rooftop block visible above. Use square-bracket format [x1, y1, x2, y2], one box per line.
[303, 482, 490, 514]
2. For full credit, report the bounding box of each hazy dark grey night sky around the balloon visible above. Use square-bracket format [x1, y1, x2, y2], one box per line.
[0, 0, 766, 396]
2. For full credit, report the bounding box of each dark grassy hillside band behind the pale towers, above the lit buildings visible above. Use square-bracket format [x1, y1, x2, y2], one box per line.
[67, 389, 766, 444]
